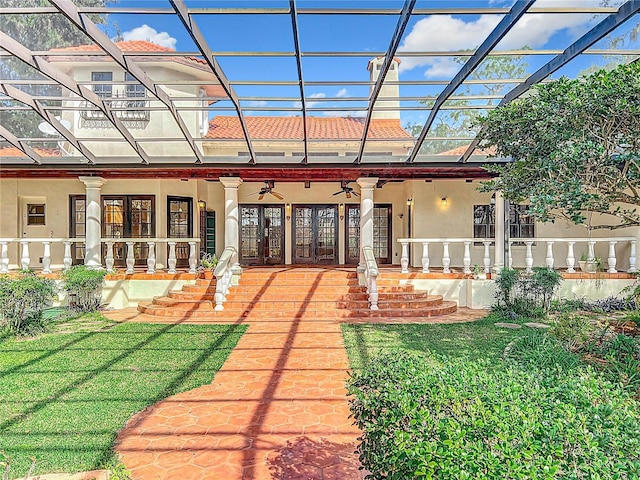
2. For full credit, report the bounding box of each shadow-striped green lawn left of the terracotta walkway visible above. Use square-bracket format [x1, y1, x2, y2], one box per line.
[0, 315, 246, 478]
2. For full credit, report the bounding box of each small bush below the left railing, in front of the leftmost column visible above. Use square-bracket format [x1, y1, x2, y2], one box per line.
[62, 265, 106, 312]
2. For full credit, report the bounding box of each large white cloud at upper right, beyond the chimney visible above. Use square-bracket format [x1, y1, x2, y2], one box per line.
[398, 12, 594, 78]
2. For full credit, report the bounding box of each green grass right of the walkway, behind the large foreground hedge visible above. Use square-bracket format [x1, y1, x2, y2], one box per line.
[342, 315, 529, 369]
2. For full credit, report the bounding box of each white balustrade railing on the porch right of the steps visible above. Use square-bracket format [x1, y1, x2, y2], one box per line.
[398, 237, 637, 273]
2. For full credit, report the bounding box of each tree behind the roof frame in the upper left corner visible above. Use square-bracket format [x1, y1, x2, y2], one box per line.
[0, 0, 110, 141]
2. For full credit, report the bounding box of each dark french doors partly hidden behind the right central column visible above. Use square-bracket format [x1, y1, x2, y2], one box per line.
[345, 204, 392, 264]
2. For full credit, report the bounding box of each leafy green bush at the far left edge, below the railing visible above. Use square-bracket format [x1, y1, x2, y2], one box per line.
[0, 270, 56, 335]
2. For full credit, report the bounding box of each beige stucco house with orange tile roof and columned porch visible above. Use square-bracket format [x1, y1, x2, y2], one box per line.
[0, 41, 640, 306]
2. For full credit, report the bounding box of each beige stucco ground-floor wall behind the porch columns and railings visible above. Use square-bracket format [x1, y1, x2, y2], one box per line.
[0, 178, 640, 270]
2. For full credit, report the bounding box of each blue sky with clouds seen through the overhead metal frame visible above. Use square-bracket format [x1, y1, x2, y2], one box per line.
[101, 0, 640, 124]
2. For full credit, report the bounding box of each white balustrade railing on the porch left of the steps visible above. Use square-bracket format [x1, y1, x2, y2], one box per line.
[0, 237, 200, 274]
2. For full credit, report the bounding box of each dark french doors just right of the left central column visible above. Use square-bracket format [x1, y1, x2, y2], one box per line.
[240, 205, 284, 265]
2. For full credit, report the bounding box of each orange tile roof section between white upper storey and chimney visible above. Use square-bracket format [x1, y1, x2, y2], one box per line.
[206, 116, 413, 140]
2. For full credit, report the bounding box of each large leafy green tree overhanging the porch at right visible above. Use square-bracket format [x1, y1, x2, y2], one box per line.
[479, 61, 640, 229]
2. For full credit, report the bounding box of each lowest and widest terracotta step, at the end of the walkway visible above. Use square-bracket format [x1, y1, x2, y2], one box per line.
[138, 301, 458, 320]
